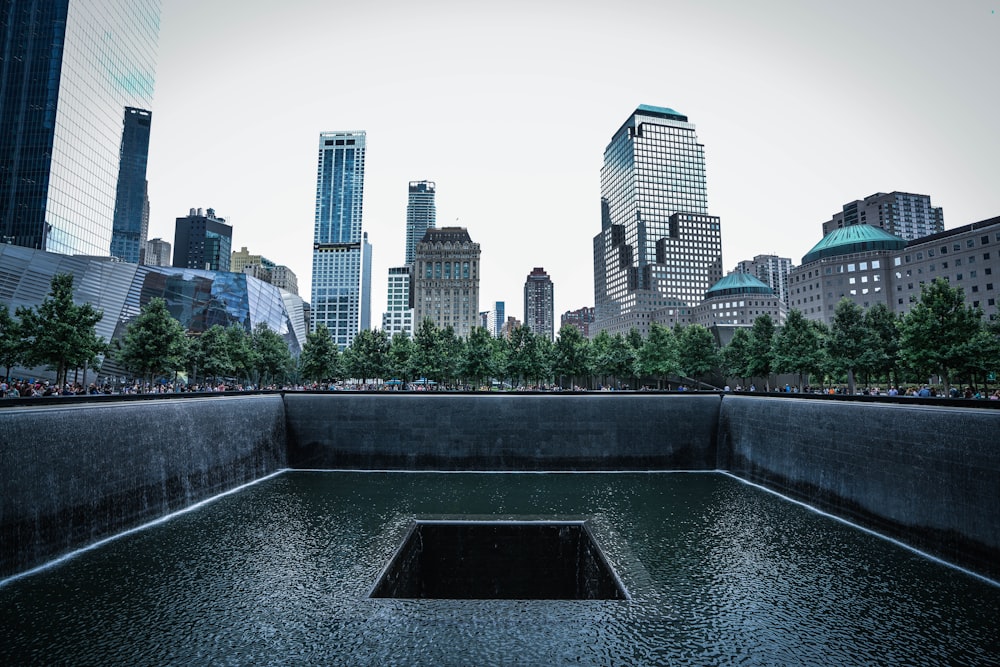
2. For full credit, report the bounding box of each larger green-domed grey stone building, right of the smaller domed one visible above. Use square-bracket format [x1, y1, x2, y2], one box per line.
[787, 225, 906, 324]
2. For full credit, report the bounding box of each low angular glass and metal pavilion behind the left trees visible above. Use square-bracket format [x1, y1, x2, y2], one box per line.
[0, 244, 306, 375]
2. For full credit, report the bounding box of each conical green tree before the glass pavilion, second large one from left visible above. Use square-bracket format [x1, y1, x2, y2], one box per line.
[115, 297, 188, 384]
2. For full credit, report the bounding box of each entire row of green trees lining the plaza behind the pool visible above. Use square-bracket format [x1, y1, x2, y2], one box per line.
[0, 275, 1000, 393]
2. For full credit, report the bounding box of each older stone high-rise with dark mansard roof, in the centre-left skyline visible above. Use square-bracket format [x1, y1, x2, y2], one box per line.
[412, 227, 480, 338]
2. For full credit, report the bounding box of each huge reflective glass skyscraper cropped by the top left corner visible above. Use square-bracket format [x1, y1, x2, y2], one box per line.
[0, 0, 160, 257]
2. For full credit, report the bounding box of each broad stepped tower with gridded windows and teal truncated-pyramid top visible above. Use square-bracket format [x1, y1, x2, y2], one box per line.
[592, 105, 722, 335]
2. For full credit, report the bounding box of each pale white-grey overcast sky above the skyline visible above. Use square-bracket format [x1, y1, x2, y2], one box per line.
[148, 0, 1000, 325]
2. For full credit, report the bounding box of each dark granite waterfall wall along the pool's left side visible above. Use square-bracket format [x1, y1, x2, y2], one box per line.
[0, 395, 287, 578]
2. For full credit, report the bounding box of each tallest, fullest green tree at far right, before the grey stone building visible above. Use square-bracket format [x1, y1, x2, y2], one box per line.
[899, 278, 982, 393]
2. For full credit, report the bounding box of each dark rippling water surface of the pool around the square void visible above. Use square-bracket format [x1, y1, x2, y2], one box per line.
[0, 472, 1000, 666]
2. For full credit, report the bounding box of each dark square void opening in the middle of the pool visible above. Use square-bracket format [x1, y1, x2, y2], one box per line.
[371, 521, 628, 600]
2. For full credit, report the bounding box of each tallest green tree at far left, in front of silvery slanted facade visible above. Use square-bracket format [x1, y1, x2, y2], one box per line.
[16, 273, 107, 386]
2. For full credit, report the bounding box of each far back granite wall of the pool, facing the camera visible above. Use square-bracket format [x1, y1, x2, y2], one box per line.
[285, 392, 721, 470]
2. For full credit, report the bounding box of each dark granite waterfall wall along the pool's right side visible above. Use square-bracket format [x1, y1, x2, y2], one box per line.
[718, 396, 1000, 580]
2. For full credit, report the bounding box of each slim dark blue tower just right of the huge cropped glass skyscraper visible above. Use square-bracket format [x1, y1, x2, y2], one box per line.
[111, 107, 153, 264]
